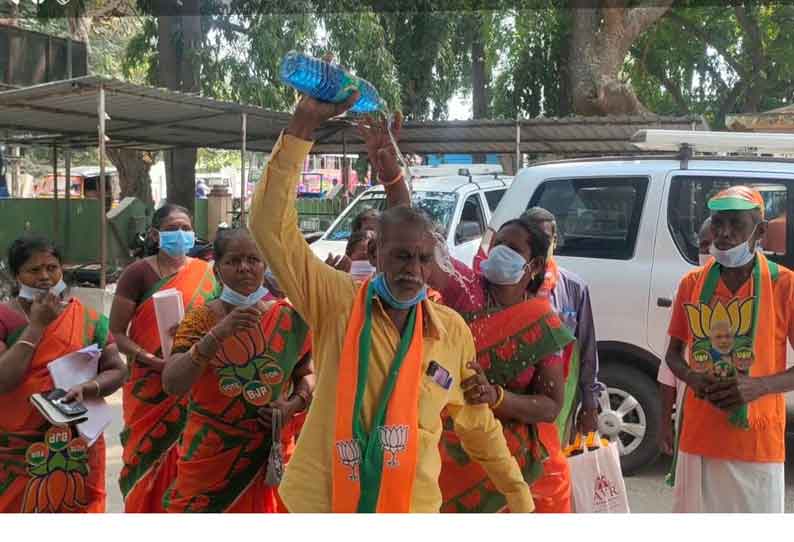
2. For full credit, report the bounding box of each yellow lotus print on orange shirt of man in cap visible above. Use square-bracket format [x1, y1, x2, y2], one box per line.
[685, 298, 754, 377]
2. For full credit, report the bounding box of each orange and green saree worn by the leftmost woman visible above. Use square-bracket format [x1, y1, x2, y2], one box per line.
[0, 299, 108, 512]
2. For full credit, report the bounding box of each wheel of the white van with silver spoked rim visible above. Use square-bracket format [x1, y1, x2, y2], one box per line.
[598, 364, 661, 475]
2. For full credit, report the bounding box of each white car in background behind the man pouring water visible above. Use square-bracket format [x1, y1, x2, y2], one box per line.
[311, 166, 512, 265]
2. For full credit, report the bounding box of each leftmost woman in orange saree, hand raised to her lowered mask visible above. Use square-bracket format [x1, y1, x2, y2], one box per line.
[0, 237, 126, 512]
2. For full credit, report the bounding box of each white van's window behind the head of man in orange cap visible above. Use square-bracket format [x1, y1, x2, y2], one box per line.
[667, 175, 788, 264]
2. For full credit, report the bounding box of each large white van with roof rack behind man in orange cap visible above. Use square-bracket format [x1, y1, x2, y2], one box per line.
[481, 130, 794, 473]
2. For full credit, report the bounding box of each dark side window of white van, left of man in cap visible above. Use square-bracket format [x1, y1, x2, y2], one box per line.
[529, 177, 648, 260]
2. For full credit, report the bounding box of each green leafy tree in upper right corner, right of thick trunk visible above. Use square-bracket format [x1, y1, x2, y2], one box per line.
[627, 3, 794, 128]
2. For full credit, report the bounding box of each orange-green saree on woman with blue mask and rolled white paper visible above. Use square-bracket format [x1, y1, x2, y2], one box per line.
[119, 259, 217, 513]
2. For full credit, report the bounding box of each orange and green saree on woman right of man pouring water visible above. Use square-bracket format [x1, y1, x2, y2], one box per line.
[439, 297, 574, 513]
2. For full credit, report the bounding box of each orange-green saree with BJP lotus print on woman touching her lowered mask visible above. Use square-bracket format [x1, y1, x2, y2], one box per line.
[163, 301, 310, 513]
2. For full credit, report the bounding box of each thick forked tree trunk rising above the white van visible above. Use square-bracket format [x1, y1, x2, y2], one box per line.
[570, 0, 673, 116]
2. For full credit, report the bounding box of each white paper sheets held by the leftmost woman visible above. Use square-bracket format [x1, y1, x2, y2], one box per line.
[47, 344, 113, 446]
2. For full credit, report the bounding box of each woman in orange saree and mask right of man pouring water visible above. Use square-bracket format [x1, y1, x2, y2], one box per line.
[435, 220, 575, 512]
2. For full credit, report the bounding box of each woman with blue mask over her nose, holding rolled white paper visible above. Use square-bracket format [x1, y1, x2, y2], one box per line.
[110, 205, 215, 513]
